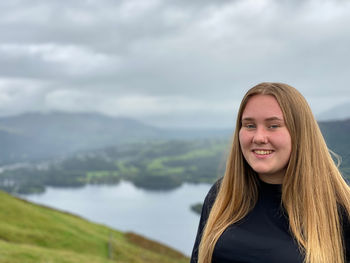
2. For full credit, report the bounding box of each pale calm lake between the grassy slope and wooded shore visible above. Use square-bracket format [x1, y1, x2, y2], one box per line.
[21, 181, 210, 256]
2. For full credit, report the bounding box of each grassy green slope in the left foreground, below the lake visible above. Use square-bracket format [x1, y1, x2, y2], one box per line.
[0, 191, 188, 263]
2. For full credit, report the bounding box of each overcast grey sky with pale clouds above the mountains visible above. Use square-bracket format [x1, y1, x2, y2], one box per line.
[0, 0, 350, 128]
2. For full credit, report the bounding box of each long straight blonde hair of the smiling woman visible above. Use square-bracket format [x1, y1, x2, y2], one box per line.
[198, 83, 350, 263]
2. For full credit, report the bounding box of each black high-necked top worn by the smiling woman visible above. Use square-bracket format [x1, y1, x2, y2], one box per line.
[191, 180, 350, 263]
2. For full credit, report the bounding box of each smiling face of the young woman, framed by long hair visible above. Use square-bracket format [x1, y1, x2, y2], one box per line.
[239, 95, 292, 184]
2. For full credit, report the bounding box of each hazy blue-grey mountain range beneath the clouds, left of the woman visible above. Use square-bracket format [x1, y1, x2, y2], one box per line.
[0, 112, 232, 165]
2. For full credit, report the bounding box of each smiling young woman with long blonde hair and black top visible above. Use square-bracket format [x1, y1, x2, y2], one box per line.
[191, 83, 350, 263]
